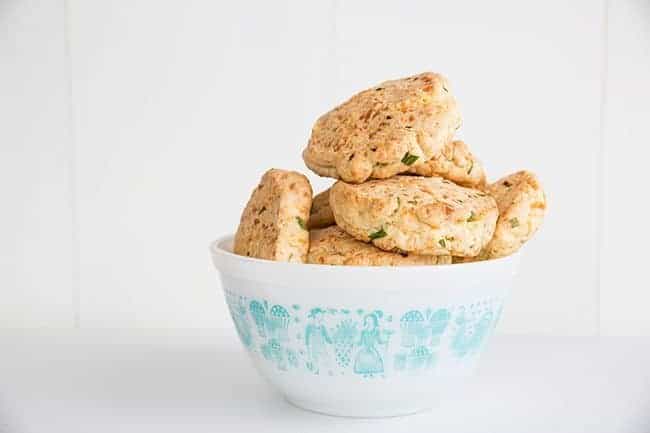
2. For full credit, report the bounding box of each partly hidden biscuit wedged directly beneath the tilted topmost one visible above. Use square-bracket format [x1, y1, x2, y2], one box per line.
[409, 140, 485, 189]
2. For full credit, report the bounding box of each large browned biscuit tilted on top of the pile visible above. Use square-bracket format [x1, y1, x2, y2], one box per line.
[303, 72, 462, 183]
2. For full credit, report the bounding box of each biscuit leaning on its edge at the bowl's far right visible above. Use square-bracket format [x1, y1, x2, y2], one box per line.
[480, 171, 546, 259]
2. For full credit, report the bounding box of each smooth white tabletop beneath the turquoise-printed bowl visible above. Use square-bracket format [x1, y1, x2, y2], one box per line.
[0, 329, 650, 433]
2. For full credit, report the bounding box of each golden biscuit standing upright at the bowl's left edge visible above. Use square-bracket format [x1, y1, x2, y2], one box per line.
[234, 169, 312, 263]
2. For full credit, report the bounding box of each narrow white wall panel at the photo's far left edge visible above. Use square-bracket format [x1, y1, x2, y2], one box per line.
[0, 0, 75, 328]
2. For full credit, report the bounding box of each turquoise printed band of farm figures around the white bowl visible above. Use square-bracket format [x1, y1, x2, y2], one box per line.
[226, 292, 502, 378]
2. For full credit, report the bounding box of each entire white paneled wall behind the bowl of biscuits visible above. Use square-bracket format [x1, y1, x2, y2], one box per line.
[0, 0, 650, 335]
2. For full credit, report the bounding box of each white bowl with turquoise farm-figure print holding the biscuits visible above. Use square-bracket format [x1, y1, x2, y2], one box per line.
[211, 236, 519, 417]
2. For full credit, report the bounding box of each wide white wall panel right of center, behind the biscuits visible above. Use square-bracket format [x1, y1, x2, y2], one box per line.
[337, 0, 604, 334]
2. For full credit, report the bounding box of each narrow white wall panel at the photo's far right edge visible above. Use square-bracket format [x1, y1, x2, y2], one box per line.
[600, 0, 650, 335]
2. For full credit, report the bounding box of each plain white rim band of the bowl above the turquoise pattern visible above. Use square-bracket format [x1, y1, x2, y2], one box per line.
[209, 234, 520, 287]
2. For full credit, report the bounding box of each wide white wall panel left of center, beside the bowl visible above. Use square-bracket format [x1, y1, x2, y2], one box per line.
[71, 0, 332, 327]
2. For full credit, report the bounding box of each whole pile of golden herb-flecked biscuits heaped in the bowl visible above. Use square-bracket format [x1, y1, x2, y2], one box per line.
[234, 72, 546, 266]
